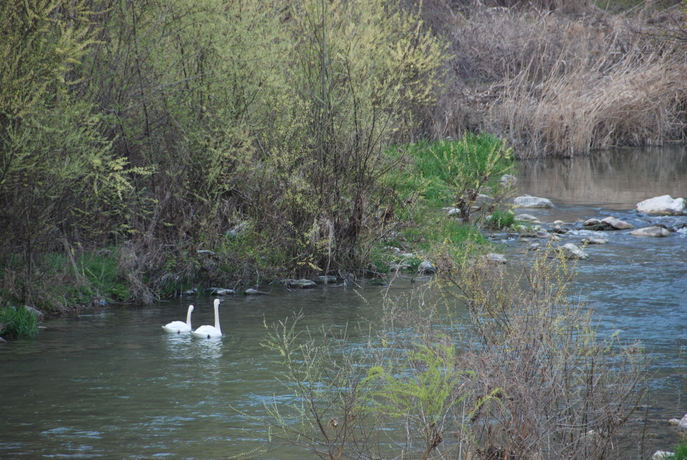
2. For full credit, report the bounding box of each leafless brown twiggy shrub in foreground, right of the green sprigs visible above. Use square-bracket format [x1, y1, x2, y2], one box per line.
[374, 248, 645, 460]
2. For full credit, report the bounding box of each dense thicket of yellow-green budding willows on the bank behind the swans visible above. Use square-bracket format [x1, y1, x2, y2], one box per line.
[0, 0, 443, 308]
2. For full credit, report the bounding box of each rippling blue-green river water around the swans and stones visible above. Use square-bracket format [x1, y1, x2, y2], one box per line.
[0, 148, 687, 459]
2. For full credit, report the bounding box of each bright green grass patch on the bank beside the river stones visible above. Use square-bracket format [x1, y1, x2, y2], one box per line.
[371, 134, 515, 272]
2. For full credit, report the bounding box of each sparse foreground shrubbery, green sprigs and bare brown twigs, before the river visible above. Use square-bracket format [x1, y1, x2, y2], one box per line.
[256, 248, 645, 460]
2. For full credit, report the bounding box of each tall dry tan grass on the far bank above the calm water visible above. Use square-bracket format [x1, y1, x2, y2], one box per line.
[426, 3, 687, 158]
